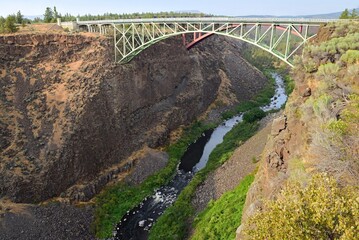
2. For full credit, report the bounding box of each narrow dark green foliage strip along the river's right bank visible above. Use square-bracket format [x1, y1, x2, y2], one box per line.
[149, 121, 258, 240]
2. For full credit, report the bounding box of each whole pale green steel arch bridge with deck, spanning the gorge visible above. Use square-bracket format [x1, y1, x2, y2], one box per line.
[77, 17, 338, 67]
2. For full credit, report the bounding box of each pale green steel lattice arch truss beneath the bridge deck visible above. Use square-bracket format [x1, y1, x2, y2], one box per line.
[109, 22, 319, 66]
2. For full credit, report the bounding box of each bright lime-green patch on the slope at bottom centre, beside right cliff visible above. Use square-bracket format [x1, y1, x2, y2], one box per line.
[192, 174, 254, 240]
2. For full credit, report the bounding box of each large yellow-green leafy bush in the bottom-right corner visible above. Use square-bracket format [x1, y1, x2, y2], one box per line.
[244, 174, 359, 240]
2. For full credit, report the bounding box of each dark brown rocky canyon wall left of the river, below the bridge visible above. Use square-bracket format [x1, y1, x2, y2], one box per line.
[0, 34, 266, 202]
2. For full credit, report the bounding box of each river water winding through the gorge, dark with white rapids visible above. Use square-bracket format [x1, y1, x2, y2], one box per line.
[113, 73, 287, 240]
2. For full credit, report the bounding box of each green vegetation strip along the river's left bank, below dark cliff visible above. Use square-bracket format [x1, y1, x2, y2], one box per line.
[92, 122, 213, 238]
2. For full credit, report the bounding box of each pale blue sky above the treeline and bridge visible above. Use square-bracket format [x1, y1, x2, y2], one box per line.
[0, 0, 359, 16]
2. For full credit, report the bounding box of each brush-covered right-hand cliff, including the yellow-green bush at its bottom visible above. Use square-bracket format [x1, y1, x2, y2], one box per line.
[236, 21, 359, 239]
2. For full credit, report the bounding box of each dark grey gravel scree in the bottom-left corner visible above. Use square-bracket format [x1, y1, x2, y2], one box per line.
[0, 203, 96, 240]
